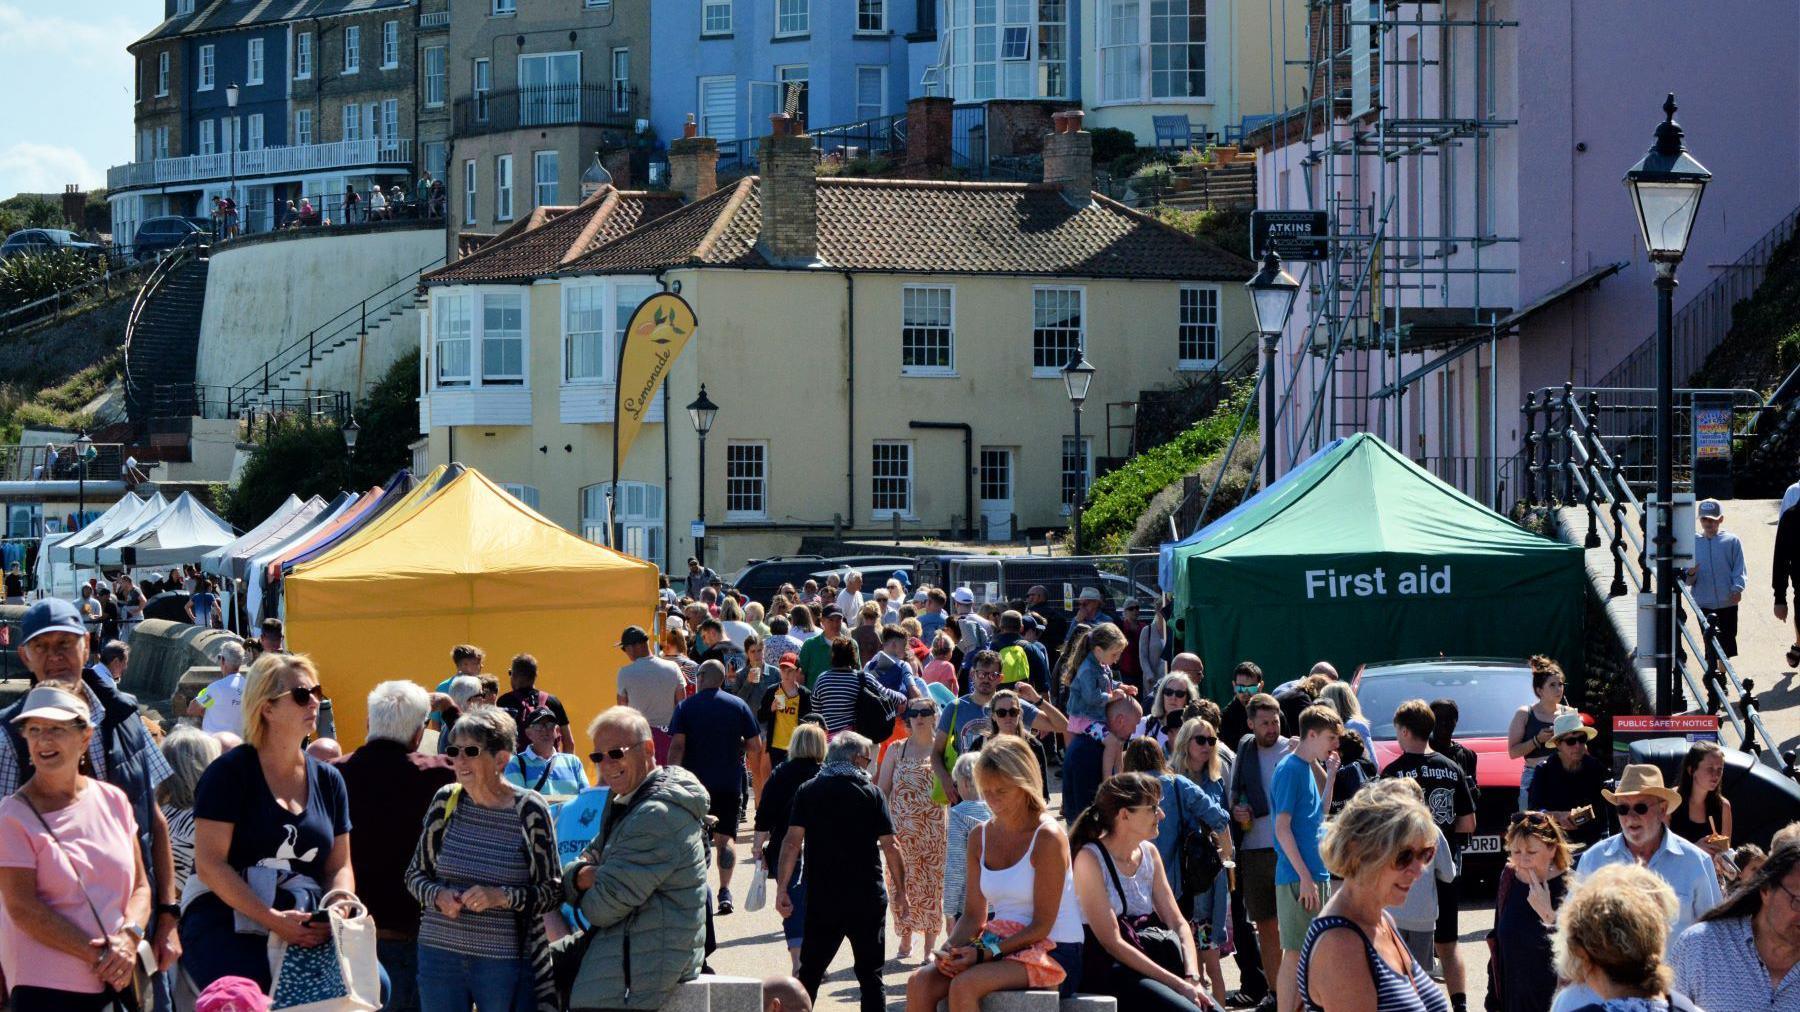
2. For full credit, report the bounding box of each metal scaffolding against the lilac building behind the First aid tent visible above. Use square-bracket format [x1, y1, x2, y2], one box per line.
[1271, 0, 1517, 501]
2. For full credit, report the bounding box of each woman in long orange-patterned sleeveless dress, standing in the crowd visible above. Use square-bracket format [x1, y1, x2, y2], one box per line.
[878, 695, 947, 960]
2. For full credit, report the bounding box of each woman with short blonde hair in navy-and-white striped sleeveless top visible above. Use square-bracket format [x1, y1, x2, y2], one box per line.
[1298, 778, 1451, 1012]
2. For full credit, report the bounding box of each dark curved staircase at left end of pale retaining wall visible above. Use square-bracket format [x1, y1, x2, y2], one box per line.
[124, 247, 209, 425]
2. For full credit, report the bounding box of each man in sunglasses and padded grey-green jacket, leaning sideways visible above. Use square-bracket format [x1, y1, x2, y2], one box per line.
[553, 706, 709, 1008]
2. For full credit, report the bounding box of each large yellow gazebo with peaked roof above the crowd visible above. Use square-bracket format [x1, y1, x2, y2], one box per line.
[284, 470, 657, 751]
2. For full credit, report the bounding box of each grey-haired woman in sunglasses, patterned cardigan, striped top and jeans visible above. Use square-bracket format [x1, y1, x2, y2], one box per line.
[407, 706, 562, 1012]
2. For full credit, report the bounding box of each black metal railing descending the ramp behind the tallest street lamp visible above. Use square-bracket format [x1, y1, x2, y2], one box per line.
[1528, 384, 1778, 754]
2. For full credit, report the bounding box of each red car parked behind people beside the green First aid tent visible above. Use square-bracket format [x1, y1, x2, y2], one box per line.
[1350, 657, 1576, 859]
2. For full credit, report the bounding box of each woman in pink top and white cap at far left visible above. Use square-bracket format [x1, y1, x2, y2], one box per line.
[0, 684, 149, 1012]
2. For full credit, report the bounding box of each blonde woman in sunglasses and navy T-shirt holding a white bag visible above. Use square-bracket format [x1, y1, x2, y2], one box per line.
[180, 654, 356, 992]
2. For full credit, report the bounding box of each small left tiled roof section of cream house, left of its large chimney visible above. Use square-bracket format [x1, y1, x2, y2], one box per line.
[419, 187, 680, 285]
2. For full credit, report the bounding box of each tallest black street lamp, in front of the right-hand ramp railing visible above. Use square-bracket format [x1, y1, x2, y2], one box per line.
[1625, 92, 1712, 717]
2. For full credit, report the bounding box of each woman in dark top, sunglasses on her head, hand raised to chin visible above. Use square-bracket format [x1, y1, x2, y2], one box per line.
[1492, 812, 1575, 1012]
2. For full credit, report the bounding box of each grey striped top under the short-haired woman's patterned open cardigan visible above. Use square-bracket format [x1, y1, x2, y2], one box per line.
[419, 796, 531, 958]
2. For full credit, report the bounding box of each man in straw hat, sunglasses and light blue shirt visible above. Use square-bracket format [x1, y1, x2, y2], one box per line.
[1577, 764, 1721, 938]
